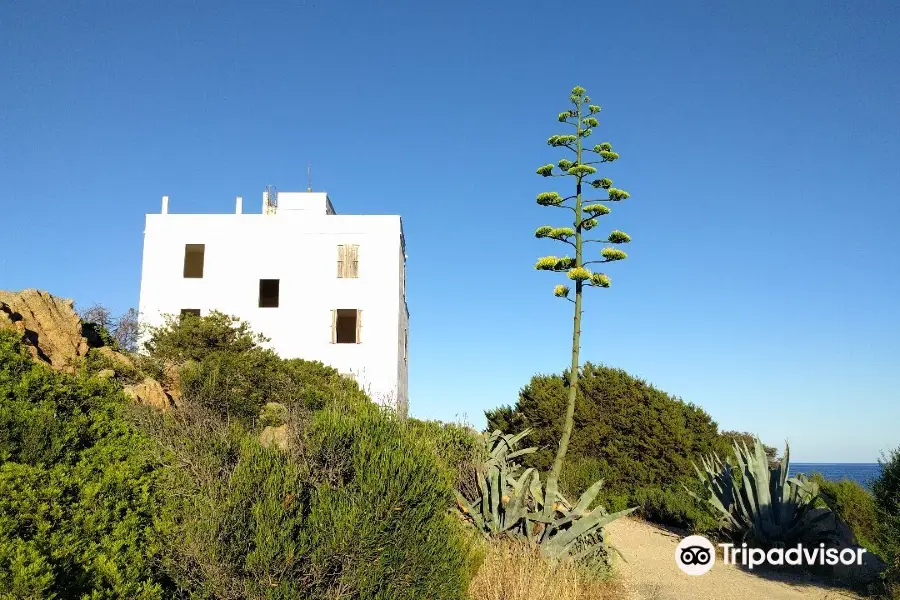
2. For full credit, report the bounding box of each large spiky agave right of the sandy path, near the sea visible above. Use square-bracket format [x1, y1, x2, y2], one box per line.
[685, 439, 845, 546]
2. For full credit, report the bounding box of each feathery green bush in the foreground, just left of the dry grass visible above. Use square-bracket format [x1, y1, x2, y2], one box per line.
[147, 402, 476, 599]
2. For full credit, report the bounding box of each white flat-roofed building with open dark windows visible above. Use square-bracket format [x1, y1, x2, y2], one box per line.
[139, 192, 409, 414]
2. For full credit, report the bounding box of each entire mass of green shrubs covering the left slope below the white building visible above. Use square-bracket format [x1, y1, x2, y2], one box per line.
[0, 314, 479, 599]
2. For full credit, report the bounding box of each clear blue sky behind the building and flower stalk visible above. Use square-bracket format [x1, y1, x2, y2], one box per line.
[0, 1, 900, 462]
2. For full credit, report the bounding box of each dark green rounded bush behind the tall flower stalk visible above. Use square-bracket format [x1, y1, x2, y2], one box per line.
[486, 363, 730, 530]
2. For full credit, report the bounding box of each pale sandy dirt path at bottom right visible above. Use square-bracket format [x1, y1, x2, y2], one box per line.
[607, 518, 858, 600]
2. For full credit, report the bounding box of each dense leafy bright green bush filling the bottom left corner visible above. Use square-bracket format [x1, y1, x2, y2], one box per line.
[0, 331, 169, 599]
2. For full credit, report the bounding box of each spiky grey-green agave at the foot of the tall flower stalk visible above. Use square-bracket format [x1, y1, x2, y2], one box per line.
[456, 429, 634, 560]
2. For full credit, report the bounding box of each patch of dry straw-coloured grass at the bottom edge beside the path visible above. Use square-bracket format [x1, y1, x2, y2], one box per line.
[469, 542, 625, 600]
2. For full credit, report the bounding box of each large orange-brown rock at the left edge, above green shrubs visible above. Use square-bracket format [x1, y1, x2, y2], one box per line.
[0, 290, 90, 373]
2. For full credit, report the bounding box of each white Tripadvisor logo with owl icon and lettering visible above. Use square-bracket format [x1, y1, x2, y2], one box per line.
[675, 535, 866, 575]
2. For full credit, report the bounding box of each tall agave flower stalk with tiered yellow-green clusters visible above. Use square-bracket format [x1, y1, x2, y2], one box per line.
[535, 87, 631, 517]
